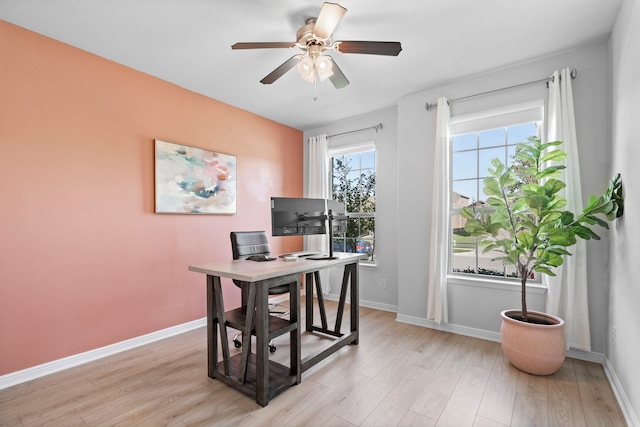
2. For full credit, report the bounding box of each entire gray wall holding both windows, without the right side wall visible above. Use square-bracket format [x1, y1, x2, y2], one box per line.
[304, 40, 611, 353]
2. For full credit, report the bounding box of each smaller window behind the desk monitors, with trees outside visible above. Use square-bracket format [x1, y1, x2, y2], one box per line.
[329, 144, 376, 262]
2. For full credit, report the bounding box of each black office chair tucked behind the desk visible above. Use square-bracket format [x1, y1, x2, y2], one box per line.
[231, 231, 289, 353]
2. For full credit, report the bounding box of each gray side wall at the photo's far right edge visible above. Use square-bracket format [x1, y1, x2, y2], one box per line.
[607, 0, 640, 426]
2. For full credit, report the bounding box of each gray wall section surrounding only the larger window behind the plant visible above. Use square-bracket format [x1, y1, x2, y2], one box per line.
[398, 40, 611, 353]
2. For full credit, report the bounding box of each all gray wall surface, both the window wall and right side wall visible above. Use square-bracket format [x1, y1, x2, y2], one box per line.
[305, 12, 640, 425]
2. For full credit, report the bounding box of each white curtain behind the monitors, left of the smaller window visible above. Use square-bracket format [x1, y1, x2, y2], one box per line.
[304, 134, 331, 293]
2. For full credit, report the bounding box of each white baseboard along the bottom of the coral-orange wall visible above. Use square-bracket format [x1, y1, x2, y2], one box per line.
[0, 317, 207, 390]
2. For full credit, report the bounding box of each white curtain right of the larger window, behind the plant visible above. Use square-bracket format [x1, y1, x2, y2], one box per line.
[543, 68, 591, 351]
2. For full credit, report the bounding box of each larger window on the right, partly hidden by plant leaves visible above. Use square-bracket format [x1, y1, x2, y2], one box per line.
[449, 102, 542, 279]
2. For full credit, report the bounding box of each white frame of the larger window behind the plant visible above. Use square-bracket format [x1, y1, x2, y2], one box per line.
[446, 99, 545, 286]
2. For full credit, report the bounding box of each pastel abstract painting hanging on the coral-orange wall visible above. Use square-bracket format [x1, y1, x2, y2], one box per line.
[155, 139, 237, 214]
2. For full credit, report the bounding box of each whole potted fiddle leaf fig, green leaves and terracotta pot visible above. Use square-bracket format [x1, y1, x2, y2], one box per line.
[461, 137, 624, 375]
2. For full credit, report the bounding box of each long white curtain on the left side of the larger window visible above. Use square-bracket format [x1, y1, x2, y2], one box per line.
[427, 98, 451, 323]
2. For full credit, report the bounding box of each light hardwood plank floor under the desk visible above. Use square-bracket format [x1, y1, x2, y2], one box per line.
[0, 301, 625, 427]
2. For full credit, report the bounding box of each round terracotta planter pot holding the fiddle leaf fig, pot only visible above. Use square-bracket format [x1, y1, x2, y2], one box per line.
[500, 310, 566, 375]
